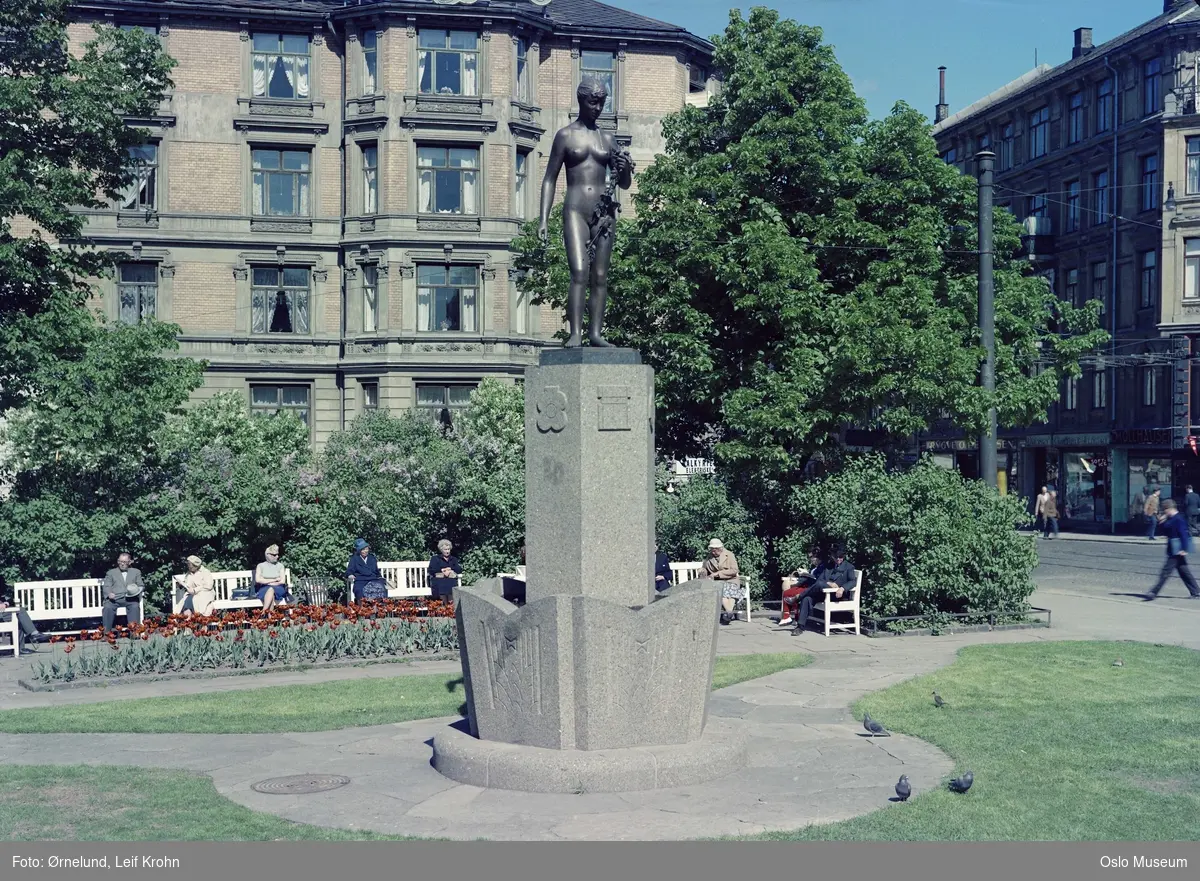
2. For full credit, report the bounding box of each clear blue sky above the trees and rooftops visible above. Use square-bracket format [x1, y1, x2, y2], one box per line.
[628, 0, 1163, 116]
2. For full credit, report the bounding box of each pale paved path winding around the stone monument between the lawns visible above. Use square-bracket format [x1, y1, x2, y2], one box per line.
[0, 588, 1200, 840]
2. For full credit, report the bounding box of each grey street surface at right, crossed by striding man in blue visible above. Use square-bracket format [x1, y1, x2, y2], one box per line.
[1033, 535, 1200, 611]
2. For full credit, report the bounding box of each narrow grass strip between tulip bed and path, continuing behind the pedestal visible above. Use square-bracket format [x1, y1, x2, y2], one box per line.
[0, 652, 812, 735]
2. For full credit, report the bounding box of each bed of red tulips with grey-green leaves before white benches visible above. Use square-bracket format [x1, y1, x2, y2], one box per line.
[34, 600, 458, 682]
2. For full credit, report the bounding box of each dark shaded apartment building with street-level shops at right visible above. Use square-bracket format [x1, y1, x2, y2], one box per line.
[922, 0, 1200, 532]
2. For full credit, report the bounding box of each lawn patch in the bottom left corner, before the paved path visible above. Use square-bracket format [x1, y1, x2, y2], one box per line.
[0, 765, 412, 841]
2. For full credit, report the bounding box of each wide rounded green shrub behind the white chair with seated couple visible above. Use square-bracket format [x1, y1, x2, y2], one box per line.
[779, 456, 1038, 621]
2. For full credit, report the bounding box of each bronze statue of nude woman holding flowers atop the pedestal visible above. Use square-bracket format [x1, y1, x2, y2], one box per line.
[538, 78, 634, 347]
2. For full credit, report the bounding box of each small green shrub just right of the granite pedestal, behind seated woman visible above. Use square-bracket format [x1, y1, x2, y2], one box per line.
[655, 467, 767, 600]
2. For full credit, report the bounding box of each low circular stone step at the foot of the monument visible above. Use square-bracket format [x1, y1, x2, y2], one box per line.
[433, 719, 749, 793]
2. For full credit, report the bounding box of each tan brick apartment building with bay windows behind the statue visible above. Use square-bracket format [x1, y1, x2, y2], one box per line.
[60, 0, 712, 445]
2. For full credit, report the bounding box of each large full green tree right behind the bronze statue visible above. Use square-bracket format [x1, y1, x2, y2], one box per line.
[515, 8, 1106, 506]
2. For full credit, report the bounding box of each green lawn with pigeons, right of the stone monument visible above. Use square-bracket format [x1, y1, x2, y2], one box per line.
[739, 642, 1200, 841]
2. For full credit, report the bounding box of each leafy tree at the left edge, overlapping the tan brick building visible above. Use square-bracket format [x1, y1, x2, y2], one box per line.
[0, 0, 174, 412]
